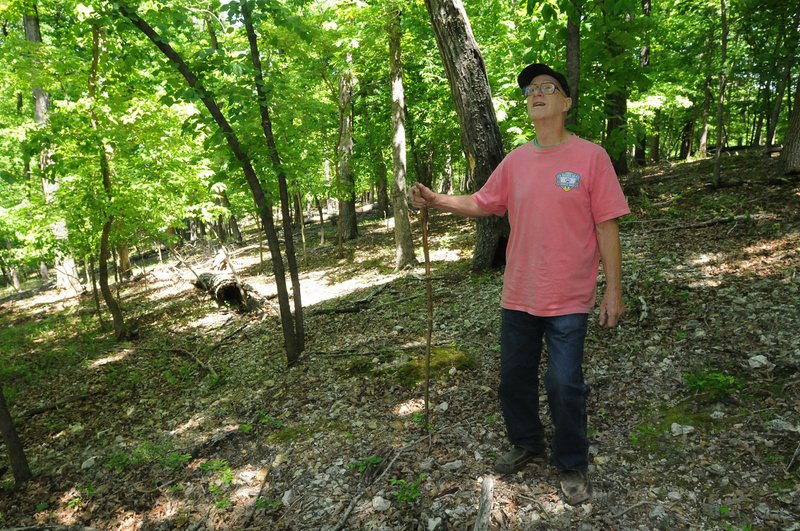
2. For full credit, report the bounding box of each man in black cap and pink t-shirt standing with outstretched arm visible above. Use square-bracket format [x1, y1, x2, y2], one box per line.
[410, 63, 630, 505]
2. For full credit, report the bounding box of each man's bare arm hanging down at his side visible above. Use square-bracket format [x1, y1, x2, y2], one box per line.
[595, 219, 625, 328]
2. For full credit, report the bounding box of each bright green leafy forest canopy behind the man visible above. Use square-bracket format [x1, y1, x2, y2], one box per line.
[0, 0, 800, 281]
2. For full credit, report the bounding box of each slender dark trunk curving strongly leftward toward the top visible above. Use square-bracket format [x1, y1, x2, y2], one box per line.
[117, 4, 302, 365]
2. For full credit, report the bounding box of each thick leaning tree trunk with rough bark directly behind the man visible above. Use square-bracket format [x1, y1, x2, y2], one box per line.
[425, 0, 504, 270]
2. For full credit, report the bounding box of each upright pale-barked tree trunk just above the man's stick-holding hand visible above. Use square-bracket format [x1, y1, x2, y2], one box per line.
[388, 3, 417, 270]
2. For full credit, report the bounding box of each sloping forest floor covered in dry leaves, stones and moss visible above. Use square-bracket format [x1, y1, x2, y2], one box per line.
[0, 153, 800, 530]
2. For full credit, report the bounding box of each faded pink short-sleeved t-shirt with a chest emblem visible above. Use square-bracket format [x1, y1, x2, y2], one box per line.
[473, 135, 630, 317]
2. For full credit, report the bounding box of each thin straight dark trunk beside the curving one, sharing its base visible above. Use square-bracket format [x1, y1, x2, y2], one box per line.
[240, 1, 305, 353]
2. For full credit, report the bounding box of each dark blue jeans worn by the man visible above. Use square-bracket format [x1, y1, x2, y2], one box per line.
[499, 309, 589, 470]
